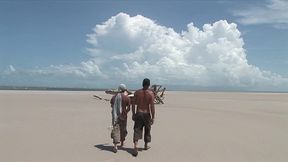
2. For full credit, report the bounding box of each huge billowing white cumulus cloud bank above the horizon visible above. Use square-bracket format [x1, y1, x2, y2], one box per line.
[2, 13, 288, 90]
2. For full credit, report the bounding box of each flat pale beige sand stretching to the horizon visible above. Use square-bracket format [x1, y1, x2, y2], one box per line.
[0, 91, 288, 162]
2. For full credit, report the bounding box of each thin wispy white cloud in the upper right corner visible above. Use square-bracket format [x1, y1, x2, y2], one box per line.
[234, 0, 288, 29]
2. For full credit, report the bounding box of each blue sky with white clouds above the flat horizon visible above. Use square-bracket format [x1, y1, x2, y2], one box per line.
[0, 0, 288, 91]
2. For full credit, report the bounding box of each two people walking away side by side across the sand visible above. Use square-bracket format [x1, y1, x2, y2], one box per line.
[110, 78, 155, 156]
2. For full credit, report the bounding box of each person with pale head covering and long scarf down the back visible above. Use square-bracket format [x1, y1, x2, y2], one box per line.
[110, 84, 130, 153]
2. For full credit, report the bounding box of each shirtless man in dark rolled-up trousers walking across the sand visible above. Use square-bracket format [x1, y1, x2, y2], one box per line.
[132, 78, 155, 156]
